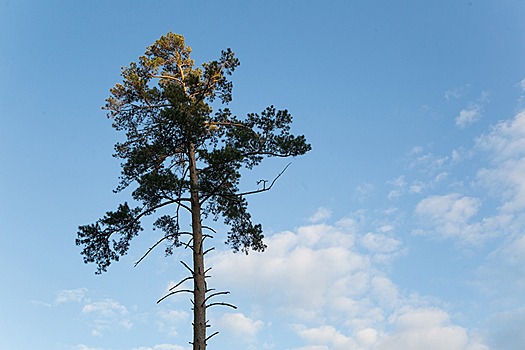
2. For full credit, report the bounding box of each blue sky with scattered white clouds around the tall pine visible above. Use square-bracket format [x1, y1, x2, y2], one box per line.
[0, 0, 525, 350]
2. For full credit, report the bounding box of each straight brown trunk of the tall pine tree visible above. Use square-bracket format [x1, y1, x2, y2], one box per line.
[189, 144, 206, 350]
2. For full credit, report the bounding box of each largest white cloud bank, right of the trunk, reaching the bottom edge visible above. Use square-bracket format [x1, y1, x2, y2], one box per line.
[209, 218, 483, 350]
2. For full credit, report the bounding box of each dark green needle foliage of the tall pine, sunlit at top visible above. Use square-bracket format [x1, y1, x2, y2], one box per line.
[76, 33, 310, 273]
